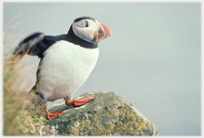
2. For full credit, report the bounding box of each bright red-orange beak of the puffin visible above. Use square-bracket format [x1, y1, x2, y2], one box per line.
[98, 23, 112, 41]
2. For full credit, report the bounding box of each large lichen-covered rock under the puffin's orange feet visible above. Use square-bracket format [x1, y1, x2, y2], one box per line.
[46, 91, 158, 136]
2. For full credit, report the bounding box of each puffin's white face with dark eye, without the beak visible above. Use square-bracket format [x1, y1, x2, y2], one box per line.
[72, 19, 101, 43]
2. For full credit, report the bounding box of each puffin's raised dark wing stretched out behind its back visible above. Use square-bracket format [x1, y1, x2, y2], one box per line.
[13, 32, 63, 58]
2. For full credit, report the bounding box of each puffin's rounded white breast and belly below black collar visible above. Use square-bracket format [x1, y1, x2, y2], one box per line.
[37, 41, 99, 101]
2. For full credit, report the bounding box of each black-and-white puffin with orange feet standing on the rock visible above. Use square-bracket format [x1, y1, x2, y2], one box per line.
[13, 16, 112, 120]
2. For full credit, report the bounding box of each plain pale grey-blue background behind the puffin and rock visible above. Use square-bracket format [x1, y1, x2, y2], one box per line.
[3, 3, 201, 136]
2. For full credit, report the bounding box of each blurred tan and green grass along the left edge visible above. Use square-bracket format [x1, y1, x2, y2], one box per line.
[3, 20, 46, 136]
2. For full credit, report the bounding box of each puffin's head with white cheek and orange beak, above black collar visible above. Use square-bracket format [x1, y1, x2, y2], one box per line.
[72, 16, 111, 44]
